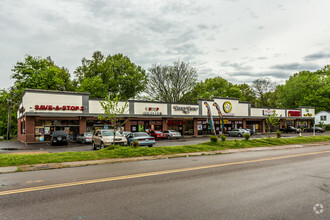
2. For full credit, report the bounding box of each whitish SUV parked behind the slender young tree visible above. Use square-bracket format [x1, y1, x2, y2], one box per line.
[92, 129, 127, 150]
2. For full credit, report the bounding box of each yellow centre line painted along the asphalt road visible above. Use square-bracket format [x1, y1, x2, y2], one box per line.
[0, 150, 330, 196]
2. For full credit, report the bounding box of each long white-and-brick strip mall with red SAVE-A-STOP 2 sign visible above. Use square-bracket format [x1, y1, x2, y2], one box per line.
[17, 89, 315, 143]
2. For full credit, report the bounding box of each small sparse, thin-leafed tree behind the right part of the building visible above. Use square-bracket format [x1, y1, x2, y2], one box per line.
[252, 78, 276, 107]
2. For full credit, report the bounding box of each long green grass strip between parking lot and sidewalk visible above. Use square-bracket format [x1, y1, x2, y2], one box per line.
[0, 135, 330, 167]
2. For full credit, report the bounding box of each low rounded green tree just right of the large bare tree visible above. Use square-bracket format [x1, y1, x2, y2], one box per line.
[184, 77, 242, 103]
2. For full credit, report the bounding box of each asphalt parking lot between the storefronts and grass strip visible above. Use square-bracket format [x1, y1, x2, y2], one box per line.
[0, 132, 330, 153]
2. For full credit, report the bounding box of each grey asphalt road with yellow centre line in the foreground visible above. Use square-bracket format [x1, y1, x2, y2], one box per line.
[0, 145, 330, 219]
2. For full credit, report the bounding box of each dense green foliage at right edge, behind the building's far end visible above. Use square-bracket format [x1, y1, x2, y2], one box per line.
[278, 65, 330, 112]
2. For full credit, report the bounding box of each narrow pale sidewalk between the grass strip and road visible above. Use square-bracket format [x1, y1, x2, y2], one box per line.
[0, 141, 330, 174]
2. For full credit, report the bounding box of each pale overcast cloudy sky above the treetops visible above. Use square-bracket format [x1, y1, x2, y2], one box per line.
[0, 0, 330, 88]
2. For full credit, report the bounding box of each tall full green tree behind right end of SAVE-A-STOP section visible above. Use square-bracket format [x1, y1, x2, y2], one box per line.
[75, 51, 147, 99]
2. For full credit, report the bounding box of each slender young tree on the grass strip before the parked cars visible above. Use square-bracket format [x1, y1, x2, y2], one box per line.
[98, 96, 128, 145]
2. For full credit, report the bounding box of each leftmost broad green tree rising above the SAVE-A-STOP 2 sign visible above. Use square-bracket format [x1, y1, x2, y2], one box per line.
[11, 55, 74, 91]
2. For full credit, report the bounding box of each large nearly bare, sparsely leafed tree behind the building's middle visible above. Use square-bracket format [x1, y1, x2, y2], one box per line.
[146, 61, 197, 102]
